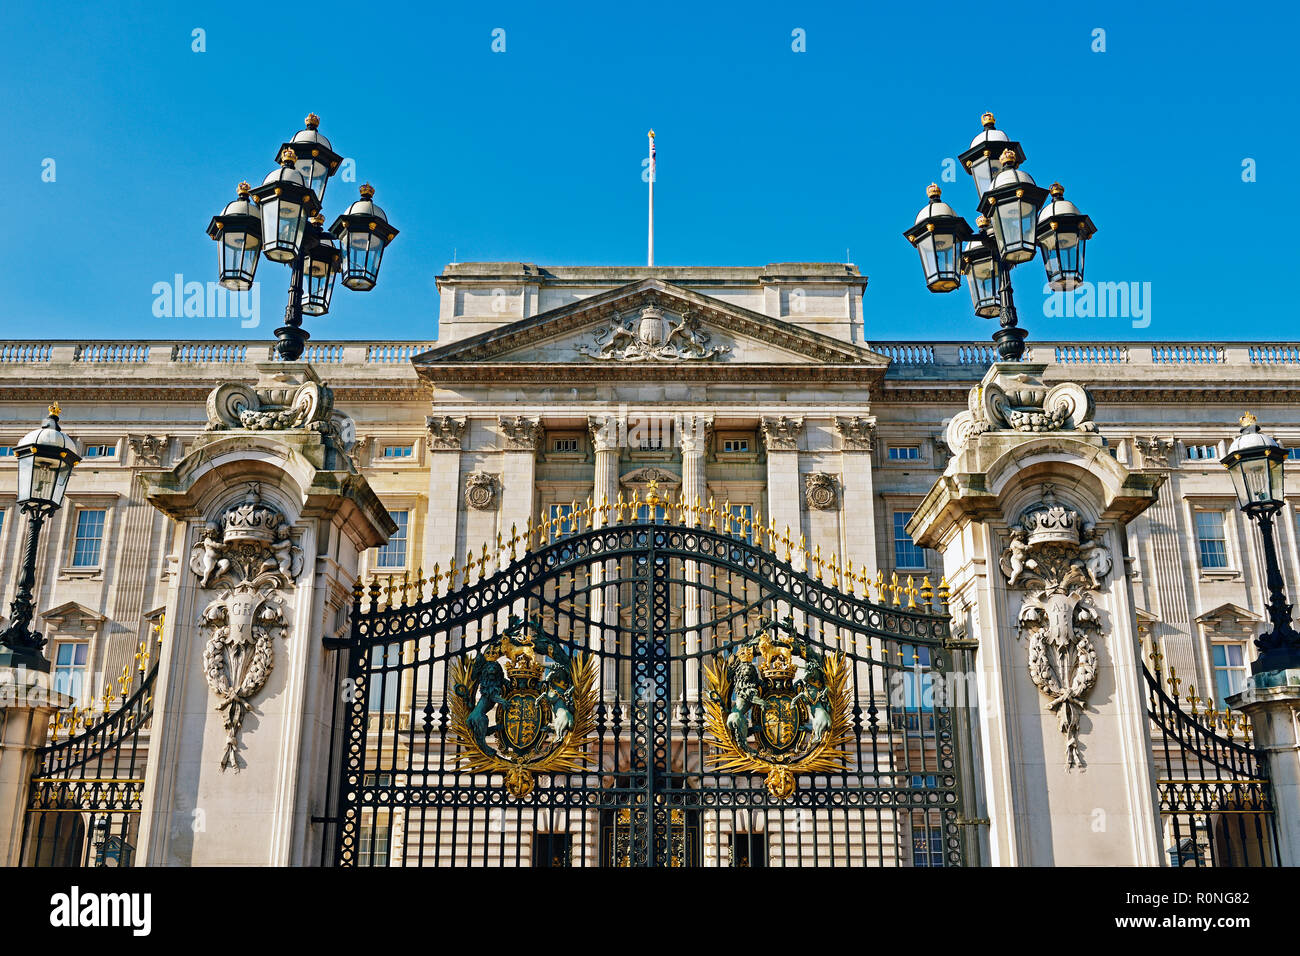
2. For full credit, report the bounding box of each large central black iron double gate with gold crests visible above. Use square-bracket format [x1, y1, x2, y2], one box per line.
[328, 499, 969, 866]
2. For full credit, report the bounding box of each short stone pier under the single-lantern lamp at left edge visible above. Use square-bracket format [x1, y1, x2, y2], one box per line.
[0, 666, 73, 866]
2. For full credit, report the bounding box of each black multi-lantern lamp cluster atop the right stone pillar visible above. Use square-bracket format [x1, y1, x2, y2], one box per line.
[904, 113, 1097, 362]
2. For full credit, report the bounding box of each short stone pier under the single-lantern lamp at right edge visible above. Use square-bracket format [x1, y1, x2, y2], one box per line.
[1227, 670, 1300, 866]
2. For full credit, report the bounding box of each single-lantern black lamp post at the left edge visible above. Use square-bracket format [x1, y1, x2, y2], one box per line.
[0, 403, 81, 672]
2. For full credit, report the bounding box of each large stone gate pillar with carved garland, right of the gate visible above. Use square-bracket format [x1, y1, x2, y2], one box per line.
[909, 363, 1162, 866]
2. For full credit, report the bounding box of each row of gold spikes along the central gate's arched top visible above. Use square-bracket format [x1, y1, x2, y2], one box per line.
[352, 481, 949, 615]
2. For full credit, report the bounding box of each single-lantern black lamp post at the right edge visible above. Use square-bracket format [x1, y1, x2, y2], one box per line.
[1223, 412, 1300, 674]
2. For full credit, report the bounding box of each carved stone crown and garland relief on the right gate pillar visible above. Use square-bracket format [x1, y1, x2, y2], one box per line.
[998, 485, 1112, 767]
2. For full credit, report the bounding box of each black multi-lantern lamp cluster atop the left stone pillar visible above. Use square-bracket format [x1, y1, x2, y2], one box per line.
[208, 113, 398, 362]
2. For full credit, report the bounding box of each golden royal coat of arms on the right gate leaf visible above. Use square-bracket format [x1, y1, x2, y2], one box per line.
[705, 624, 853, 800]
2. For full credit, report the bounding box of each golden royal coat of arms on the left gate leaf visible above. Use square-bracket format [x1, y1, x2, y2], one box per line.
[451, 617, 597, 800]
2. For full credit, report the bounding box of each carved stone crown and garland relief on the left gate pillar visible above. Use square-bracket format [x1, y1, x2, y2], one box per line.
[190, 484, 303, 771]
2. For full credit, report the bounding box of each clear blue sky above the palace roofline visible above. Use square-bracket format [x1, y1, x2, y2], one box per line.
[0, 0, 1300, 341]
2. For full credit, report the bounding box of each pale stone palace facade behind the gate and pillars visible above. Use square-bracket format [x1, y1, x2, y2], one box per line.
[0, 263, 1300, 868]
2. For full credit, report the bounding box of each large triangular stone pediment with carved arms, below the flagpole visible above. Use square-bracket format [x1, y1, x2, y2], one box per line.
[412, 278, 889, 376]
